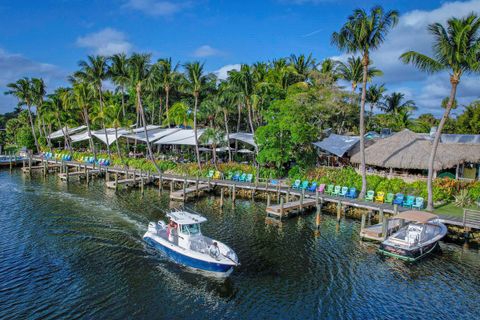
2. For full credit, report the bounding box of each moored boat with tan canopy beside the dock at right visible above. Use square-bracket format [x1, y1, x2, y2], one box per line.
[379, 210, 447, 261]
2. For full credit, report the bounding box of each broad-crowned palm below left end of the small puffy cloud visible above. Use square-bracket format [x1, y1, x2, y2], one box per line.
[74, 55, 111, 157]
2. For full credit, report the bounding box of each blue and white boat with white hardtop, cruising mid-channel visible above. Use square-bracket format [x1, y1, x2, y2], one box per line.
[143, 211, 239, 277]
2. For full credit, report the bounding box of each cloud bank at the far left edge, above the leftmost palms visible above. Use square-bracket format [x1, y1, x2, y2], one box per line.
[0, 48, 67, 113]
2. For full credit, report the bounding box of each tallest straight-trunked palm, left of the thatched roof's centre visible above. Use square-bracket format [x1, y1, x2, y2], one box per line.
[332, 6, 398, 197]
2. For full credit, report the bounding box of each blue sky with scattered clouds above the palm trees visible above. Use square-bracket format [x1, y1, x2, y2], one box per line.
[0, 0, 480, 115]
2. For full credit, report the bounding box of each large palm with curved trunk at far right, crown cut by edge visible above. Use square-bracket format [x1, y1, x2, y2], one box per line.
[400, 13, 480, 210]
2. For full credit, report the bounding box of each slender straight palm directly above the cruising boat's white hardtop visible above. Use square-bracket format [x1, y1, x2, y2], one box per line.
[185, 61, 207, 169]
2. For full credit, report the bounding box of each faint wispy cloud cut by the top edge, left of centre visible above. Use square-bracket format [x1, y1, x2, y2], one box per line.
[124, 0, 191, 16]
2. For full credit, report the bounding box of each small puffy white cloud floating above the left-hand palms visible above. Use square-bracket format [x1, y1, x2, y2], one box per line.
[76, 28, 133, 56]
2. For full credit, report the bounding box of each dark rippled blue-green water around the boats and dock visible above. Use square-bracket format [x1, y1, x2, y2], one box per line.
[0, 171, 480, 319]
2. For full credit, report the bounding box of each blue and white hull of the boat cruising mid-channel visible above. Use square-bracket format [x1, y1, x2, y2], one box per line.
[143, 233, 233, 276]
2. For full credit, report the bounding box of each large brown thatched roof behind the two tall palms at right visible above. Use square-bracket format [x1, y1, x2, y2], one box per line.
[351, 129, 480, 179]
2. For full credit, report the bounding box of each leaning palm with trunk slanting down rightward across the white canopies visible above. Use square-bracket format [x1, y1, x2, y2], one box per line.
[128, 53, 161, 173]
